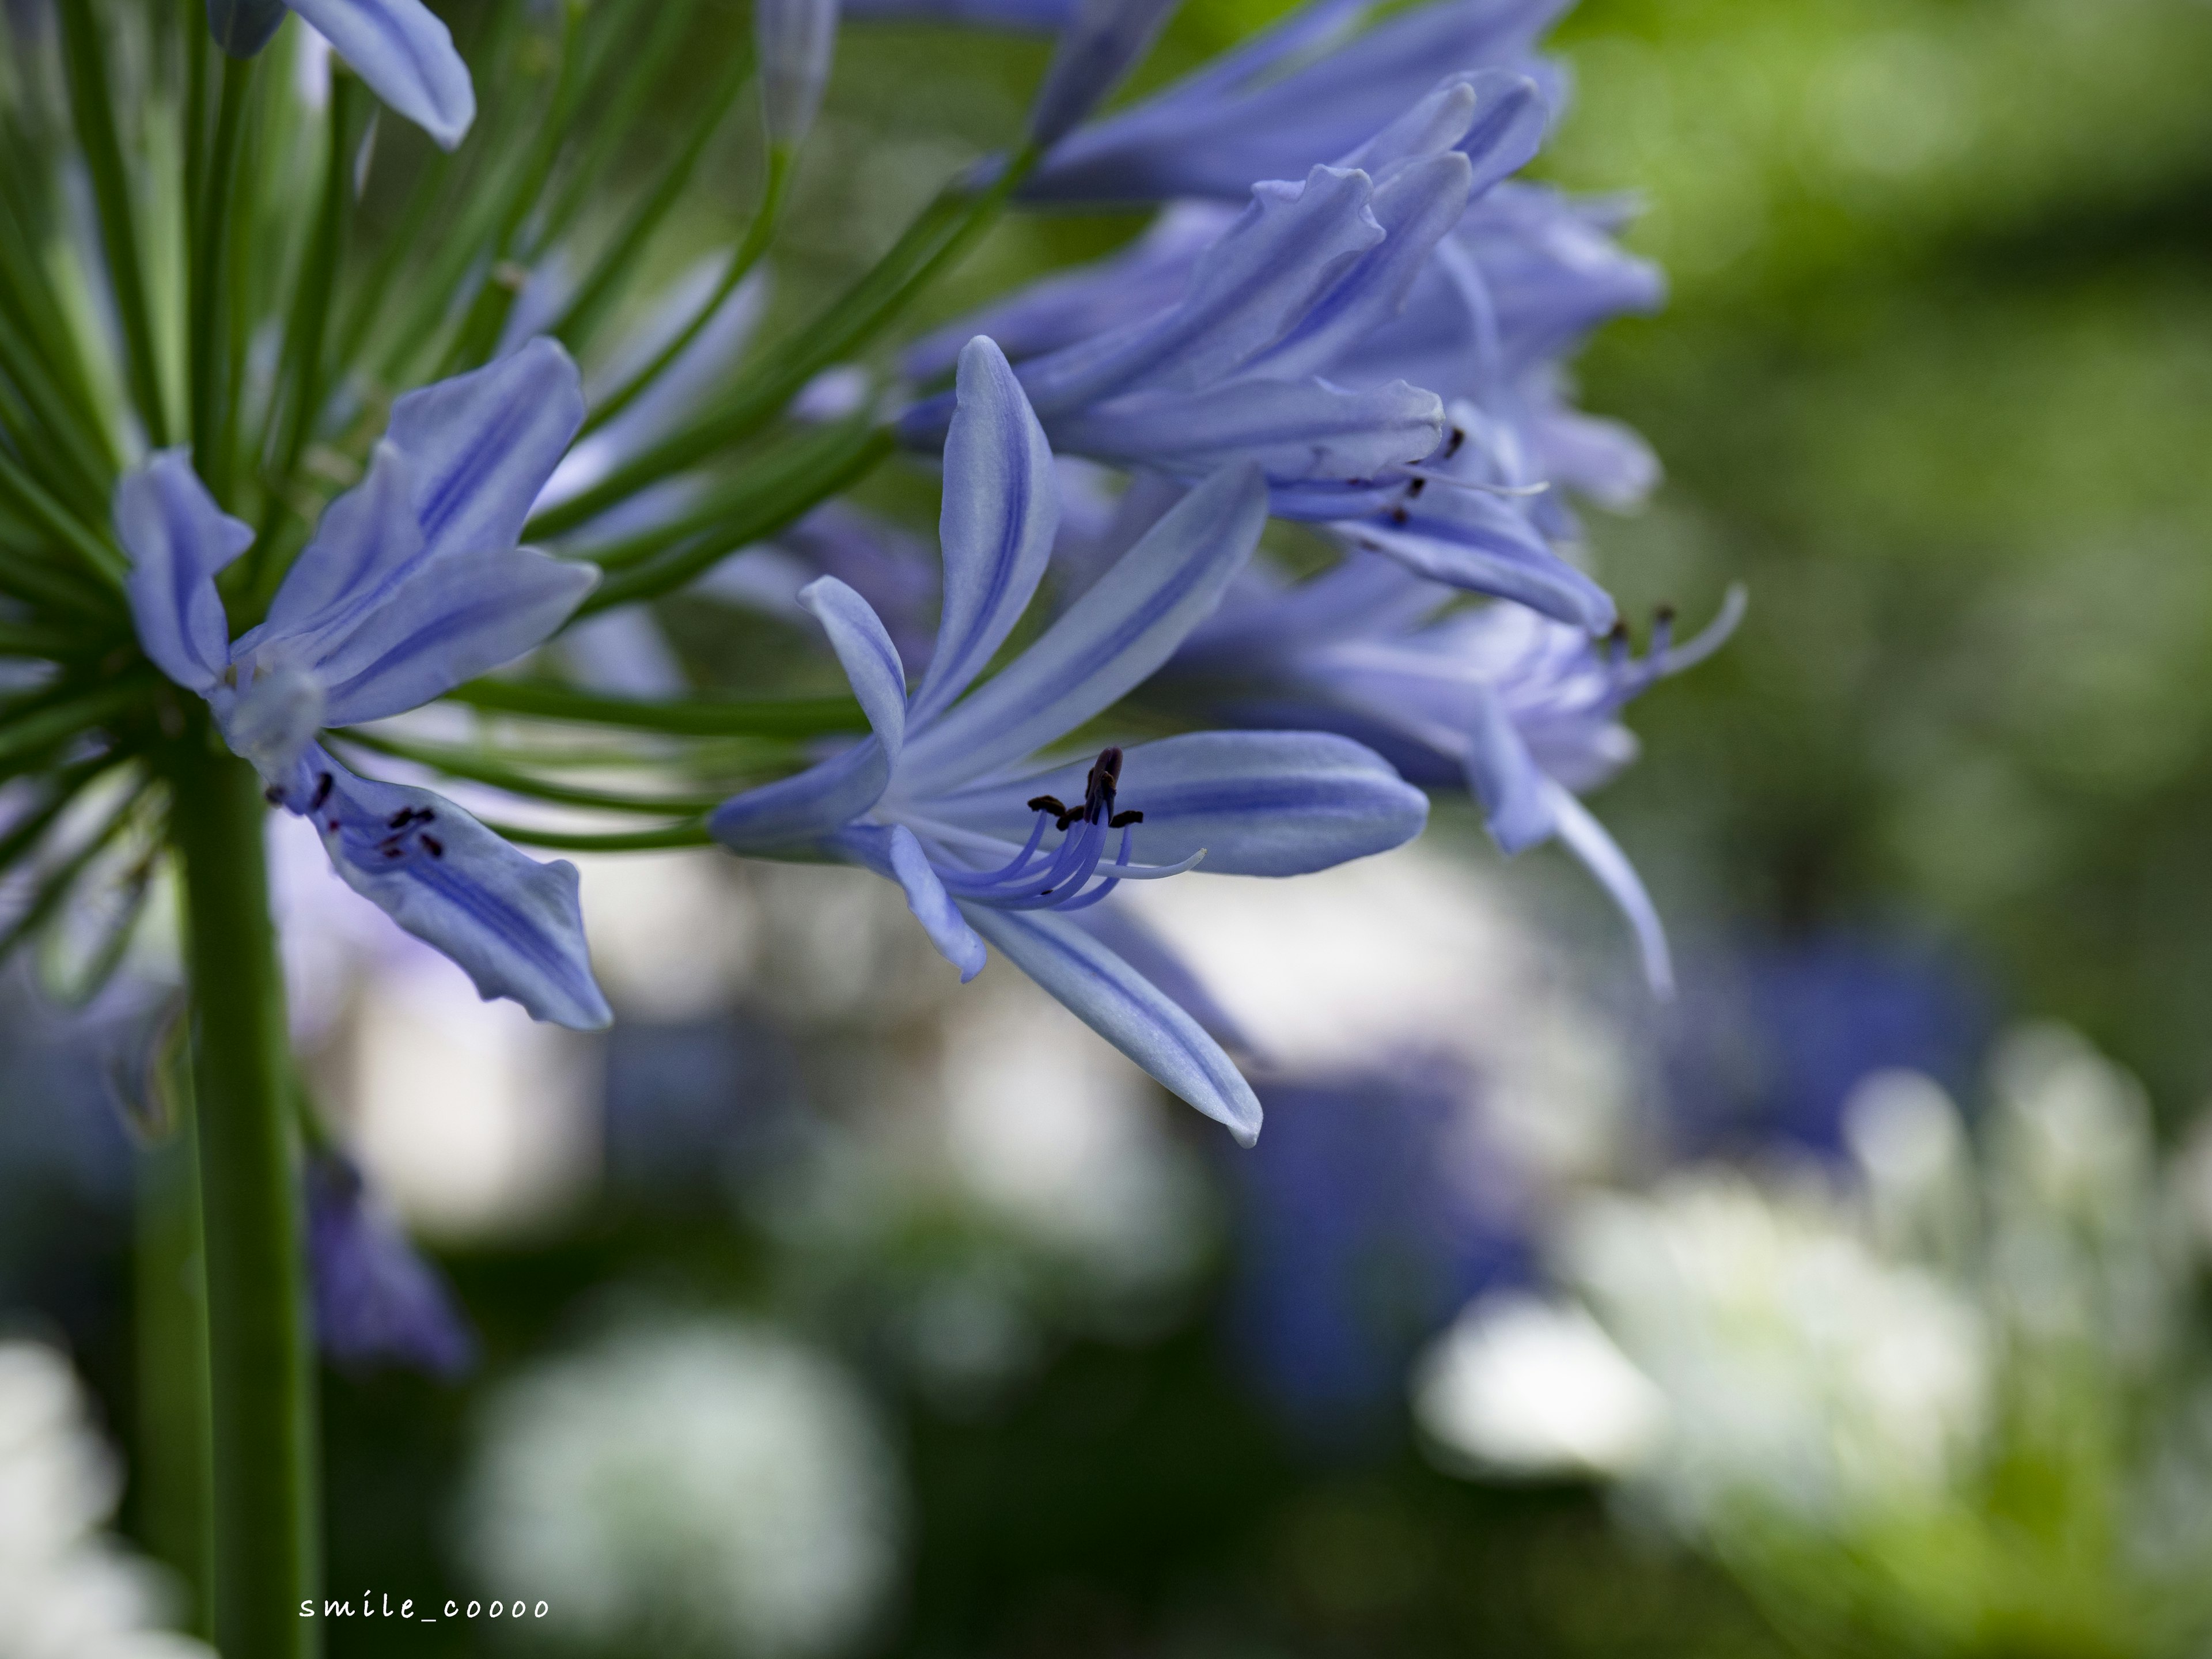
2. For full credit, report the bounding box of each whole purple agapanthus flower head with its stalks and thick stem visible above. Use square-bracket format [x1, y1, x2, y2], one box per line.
[0, 0, 1710, 1652]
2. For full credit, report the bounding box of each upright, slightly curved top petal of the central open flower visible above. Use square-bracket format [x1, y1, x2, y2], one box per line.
[914, 336, 1059, 721]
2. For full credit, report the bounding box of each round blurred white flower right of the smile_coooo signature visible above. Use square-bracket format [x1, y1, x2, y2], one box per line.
[463, 1319, 905, 1657]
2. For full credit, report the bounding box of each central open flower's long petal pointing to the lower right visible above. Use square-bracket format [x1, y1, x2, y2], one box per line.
[962, 905, 1261, 1146]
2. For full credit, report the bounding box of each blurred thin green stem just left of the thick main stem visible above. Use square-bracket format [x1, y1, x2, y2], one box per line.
[132, 1053, 214, 1641]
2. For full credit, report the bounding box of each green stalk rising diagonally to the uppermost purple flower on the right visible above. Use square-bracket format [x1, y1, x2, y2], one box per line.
[529, 148, 1037, 537]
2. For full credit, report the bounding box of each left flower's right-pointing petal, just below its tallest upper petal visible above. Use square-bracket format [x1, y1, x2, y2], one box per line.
[316, 546, 600, 726]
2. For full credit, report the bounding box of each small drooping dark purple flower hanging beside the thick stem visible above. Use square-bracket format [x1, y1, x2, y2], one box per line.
[308, 1153, 476, 1378]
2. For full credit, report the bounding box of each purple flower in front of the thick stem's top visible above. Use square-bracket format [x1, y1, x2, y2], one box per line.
[115, 340, 611, 1029]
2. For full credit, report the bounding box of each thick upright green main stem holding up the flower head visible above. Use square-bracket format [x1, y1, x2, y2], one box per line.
[171, 738, 319, 1659]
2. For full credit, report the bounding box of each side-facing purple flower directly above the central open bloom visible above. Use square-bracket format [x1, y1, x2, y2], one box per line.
[900, 75, 1541, 539]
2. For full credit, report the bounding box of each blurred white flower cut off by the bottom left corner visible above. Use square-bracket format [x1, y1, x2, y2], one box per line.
[0, 1340, 213, 1659]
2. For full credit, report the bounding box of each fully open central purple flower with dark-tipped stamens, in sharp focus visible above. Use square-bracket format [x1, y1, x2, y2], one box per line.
[710, 339, 1427, 1141]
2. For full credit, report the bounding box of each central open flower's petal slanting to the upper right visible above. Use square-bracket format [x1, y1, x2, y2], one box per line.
[900, 467, 1267, 794]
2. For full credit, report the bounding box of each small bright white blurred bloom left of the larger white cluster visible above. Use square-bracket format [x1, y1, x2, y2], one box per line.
[1414, 1292, 1666, 1475]
